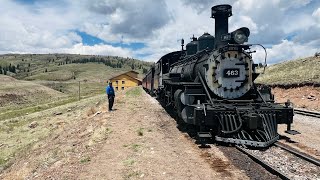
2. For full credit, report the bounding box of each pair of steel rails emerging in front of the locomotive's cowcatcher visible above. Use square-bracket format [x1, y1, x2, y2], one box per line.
[236, 142, 320, 180]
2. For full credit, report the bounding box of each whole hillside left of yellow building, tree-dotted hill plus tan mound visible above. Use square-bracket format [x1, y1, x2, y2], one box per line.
[0, 54, 152, 120]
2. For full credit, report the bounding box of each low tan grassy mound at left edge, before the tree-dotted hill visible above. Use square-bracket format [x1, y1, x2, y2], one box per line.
[0, 75, 70, 120]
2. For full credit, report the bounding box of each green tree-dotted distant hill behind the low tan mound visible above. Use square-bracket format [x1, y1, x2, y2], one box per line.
[0, 54, 152, 96]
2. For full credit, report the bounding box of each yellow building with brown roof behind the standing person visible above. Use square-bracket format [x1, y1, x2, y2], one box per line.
[109, 71, 142, 90]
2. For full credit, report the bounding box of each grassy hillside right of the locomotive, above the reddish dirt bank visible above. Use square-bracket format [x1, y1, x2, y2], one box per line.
[256, 57, 320, 85]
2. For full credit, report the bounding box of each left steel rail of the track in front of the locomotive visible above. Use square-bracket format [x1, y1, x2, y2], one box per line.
[236, 146, 290, 180]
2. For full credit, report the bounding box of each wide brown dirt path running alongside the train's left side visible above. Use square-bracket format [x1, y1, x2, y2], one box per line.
[0, 88, 248, 179]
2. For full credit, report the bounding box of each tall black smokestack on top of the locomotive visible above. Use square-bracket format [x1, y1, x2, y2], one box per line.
[211, 4, 232, 49]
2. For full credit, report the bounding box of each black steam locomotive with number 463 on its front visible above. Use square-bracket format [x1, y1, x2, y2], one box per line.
[142, 5, 293, 147]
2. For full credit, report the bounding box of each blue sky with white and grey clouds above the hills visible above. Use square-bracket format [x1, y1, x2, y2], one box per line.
[0, 0, 320, 63]
